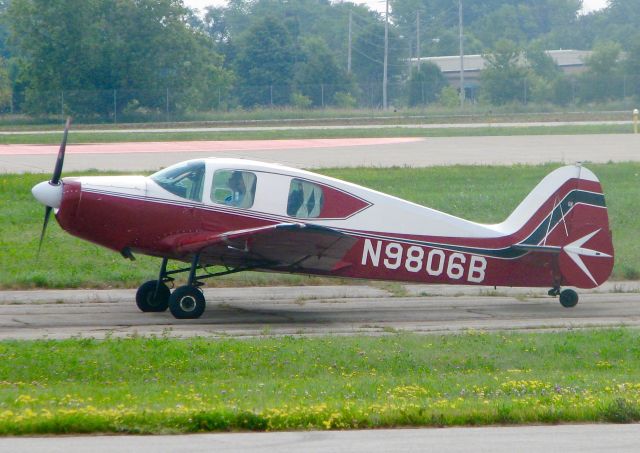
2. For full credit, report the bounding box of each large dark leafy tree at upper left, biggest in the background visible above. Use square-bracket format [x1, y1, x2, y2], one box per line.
[6, 0, 230, 114]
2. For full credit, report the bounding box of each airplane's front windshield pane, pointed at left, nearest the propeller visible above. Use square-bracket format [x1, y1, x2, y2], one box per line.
[151, 161, 205, 201]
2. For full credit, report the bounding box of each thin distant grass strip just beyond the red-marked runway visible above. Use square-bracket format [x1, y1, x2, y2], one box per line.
[0, 124, 633, 145]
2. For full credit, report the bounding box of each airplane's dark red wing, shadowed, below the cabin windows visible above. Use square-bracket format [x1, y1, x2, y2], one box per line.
[162, 223, 357, 272]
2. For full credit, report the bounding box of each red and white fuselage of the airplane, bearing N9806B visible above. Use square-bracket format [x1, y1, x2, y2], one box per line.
[42, 158, 608, 286]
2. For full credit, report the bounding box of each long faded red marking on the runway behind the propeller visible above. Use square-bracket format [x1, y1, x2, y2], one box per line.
[0, 137, 421, 156]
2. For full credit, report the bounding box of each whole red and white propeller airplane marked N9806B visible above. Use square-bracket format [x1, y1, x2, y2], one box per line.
[32, 120, 614, 318]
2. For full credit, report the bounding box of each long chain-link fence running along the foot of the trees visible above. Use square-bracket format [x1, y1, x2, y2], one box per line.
[0, 75, 640, 123]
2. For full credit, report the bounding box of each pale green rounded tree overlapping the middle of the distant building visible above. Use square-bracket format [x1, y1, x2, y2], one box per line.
[480, 40, 526, 105]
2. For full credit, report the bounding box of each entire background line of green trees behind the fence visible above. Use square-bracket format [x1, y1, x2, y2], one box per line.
[0, 0, 640, 116]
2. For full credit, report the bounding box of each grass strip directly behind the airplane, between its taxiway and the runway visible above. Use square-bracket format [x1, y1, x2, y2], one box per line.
[0, 163, 640, 289]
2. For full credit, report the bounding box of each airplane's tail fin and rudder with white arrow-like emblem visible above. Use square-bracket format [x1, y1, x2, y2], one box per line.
[498, 165, 614, 288]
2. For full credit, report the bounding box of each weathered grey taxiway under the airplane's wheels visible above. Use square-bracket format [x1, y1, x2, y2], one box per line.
[0, 282, 640, 339]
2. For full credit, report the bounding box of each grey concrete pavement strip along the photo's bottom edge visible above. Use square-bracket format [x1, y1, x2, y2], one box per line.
[0, 424, 640, 453]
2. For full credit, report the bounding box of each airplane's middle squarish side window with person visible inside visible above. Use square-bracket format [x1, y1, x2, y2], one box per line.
[211, 170, 257, 209]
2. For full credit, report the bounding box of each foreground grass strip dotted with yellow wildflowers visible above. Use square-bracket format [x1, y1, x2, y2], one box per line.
[0, 329, 640, 435]
